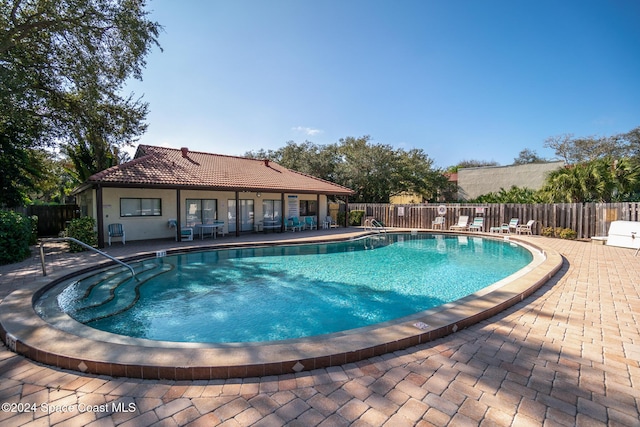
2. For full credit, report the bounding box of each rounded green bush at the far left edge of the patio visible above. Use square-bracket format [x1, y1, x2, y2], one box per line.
[0, 211, 33, 265]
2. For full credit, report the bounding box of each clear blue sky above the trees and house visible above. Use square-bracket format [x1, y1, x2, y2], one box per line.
[126, 0, 640, 168]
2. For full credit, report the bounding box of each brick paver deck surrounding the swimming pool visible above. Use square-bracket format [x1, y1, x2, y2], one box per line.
[0, 230, 640, 427]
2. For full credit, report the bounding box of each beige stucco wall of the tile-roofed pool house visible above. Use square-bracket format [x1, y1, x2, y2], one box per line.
[78, 188, 328, 241]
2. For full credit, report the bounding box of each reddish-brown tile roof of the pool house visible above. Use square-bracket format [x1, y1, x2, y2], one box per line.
[89, 145, 353, 195]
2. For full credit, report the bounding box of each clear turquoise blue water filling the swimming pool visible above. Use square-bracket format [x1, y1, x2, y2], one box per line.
[36, 234, 532, 343]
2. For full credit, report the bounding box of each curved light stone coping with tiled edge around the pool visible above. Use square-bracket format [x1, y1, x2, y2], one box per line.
[0, 229, 563, 380]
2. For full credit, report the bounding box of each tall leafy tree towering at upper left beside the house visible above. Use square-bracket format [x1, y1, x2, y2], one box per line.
[0, 0, 161, 204]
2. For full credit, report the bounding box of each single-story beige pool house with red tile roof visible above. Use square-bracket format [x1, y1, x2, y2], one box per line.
[74, 145, 353, 247]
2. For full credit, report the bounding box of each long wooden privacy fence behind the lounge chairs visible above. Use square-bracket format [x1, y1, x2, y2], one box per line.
[349, 202, 640, 238]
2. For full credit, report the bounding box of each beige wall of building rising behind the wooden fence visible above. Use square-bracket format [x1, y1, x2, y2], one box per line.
[458, 162, 564, 200]
